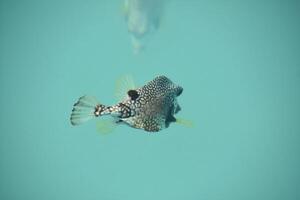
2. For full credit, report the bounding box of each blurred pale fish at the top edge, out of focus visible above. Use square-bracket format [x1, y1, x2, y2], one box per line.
[123, 0, 165, 54]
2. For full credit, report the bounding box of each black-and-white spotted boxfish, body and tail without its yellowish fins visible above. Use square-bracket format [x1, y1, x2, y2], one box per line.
[70, 75, 188, 132]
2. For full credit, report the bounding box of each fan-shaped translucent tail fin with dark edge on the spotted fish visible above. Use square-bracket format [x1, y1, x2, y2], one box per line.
[70, 96, 101, 125]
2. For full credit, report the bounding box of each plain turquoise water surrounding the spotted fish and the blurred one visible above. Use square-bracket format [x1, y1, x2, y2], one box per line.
[0, 0, 300, 200]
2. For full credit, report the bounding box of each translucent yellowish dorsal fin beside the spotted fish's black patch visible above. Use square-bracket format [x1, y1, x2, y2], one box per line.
[115, 75, 136, 101]
